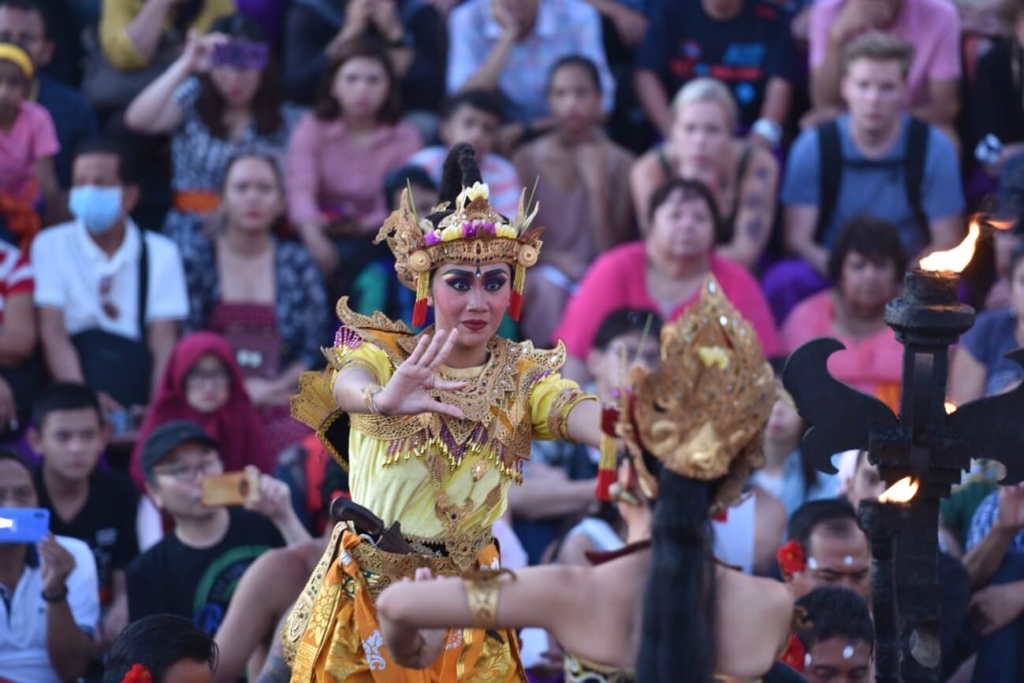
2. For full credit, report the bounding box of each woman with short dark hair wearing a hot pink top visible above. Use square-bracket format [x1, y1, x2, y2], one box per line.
[554, 178, 781, 379]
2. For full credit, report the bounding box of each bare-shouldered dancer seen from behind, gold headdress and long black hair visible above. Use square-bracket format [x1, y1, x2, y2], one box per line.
[379, 279, 803, 683]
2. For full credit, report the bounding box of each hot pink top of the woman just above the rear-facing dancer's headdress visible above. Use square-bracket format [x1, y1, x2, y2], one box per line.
[554, 242, 782, 358]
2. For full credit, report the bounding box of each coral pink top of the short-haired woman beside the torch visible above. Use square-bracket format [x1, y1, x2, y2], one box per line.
[782, 291, 903, 396]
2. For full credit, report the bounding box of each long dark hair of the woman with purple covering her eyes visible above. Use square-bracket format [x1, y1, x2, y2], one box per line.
[196, 14, 284, 139]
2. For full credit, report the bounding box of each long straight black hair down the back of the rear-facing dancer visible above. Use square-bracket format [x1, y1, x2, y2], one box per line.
[637, 454, 720, 683]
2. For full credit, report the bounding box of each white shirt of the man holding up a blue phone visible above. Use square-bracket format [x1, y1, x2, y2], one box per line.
[0, 536, 99, 683]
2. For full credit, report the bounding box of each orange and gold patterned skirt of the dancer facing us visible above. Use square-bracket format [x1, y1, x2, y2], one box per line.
[282, 524, 526, 683]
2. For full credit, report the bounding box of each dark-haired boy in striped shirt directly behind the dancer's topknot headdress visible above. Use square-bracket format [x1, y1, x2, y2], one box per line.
[407, 90, 520, 216]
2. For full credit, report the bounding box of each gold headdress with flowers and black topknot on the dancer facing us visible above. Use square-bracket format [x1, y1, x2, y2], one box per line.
[374, 144, 544, 327]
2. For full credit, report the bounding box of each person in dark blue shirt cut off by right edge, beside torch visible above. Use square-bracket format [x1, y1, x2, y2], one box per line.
[949, 246, 1024, 405]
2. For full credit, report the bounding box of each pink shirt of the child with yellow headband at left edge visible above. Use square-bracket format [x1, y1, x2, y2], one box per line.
[0, 102, 60, 200]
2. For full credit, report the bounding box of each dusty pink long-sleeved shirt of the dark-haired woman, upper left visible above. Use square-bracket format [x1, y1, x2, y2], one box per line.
[287, 114, 423, 230]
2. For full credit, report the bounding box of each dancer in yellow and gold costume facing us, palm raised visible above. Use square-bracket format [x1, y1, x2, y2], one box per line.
[284, 144, 601, 683]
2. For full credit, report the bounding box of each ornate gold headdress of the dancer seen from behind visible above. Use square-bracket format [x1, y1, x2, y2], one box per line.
[616, 278, 778, 515]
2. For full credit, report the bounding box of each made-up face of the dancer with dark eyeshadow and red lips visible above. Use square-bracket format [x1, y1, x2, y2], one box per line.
[430, 263, 512, 348]
